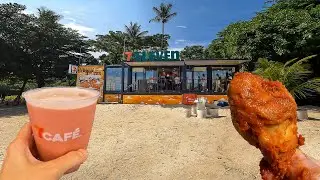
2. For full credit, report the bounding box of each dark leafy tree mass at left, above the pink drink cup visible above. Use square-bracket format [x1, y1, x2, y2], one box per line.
[0, 3, 89, 97]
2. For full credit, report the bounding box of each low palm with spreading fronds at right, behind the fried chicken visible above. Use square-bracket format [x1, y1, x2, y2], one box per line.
[254, 56, 320, 99]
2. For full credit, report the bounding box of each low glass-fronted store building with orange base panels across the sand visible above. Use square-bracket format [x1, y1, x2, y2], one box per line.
[77, 59, 248, 104]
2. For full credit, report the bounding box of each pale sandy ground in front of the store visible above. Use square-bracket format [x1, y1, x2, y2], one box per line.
[0, 105, 320, 180]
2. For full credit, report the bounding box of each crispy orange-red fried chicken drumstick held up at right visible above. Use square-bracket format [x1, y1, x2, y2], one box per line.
[228, 72, 304, 179]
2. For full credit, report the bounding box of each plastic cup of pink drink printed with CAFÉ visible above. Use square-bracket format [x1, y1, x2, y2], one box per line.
[23, 87, 99, 161]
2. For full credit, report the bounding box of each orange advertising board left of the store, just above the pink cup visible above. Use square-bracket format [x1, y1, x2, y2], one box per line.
[77, 65, 104, 102]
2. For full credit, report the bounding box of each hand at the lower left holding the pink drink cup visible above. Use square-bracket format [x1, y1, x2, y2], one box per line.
[0, 123, 87, 180]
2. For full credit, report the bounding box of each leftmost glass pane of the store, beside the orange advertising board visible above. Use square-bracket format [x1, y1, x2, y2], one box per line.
[105, 67, 122, 91]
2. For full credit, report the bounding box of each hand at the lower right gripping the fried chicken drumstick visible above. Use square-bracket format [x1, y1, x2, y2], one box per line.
[260, 149, 320, 180]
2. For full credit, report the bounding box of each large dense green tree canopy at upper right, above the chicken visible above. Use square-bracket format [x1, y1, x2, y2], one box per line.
[208, 0, 320, 72]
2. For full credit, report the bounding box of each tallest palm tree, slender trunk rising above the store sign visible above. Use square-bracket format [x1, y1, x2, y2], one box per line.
[149, 3, 177, 49]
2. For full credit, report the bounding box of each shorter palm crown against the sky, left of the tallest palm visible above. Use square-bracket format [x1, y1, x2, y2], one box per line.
[125, 22, 148, 49]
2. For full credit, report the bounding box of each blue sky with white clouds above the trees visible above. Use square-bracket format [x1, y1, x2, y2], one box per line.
[0, 0, 265, 50]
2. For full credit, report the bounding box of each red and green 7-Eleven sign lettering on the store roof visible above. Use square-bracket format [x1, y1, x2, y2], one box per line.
[124, 51, 180, 62]
